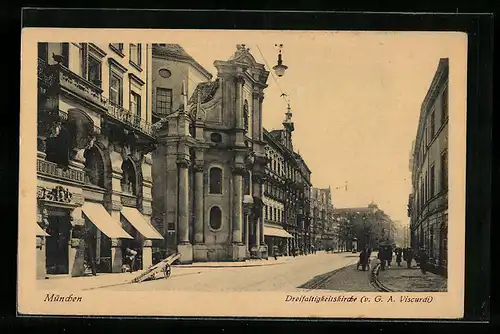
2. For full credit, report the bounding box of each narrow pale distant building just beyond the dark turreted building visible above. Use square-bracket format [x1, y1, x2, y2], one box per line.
[311, 187, 338, 250]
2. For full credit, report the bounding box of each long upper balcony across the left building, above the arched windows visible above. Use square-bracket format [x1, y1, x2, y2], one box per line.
[38, 58, 155, 138]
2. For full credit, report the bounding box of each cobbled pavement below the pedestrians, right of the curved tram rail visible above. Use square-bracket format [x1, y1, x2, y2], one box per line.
[378, 262, 448, 292]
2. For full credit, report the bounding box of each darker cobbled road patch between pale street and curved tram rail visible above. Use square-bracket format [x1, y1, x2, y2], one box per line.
[302, 260, 378, 292]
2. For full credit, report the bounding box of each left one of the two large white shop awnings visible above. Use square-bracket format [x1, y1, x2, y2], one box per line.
[82, 202, 134, 239]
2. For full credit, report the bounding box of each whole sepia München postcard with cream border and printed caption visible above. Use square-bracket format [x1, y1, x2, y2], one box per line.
[18, 29, 467, 318]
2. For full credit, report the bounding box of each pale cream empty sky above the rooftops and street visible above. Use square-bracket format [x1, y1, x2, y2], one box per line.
[180, 32, 463, 223]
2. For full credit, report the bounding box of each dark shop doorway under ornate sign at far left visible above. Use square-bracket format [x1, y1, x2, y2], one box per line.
[45, 212, 71, 275]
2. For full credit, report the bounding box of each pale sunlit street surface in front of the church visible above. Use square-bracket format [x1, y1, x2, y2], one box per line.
[101, 252, 358, 291]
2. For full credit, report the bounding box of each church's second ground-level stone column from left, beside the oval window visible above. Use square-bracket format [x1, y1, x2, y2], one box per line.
[193, 163, 208, 261]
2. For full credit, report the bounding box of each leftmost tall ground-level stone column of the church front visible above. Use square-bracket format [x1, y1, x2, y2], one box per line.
[177, 158, 193, 264]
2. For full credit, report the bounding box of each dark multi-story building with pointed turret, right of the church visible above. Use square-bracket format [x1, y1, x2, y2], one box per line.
[263, 106, 311, 255]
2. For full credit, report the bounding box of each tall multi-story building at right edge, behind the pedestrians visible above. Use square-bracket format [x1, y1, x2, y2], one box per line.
[408, 58, 449, 274]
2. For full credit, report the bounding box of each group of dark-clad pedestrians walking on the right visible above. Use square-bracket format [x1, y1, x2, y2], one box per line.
[357, 245, 429, 274]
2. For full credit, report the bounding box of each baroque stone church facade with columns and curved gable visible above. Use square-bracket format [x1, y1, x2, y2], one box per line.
[153, 45, 269, 263]
